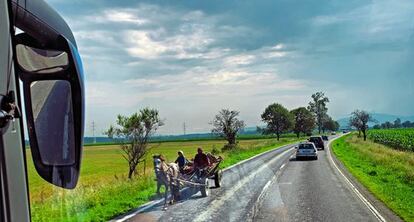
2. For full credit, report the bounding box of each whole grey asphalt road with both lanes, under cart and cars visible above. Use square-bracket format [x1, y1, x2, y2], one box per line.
[124, 135, 386, 221]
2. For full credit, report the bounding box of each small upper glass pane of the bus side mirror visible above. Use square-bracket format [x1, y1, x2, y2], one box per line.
[16, 44, 69, 73]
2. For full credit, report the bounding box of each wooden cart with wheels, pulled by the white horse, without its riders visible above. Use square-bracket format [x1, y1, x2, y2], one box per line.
[179, 154, 223, 197]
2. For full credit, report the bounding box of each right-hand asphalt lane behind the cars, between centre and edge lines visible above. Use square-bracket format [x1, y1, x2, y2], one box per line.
[254, 136, 379, 222]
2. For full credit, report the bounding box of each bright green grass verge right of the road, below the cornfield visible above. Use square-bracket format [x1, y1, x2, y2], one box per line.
[332, 134, 414, 221]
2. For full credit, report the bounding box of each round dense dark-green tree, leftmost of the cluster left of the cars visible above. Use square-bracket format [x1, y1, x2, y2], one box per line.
[261, 103, 293, 140]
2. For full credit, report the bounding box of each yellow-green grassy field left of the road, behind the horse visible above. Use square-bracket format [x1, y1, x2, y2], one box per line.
[27, 137, 303, 221]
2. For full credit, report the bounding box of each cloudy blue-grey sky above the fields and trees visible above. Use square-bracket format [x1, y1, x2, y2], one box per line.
[47, 0, 414, 136]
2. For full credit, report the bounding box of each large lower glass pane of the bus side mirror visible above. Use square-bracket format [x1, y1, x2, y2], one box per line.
[30, 80, 75, 166]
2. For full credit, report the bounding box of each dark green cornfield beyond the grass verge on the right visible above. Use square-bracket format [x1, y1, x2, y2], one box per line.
[368, 128, 414, 151]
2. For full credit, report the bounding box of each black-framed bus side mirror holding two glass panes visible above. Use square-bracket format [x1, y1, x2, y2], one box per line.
[15, 33, 84, 189]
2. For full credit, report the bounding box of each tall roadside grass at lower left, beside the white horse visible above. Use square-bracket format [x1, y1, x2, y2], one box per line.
[31, 177, 155, 221]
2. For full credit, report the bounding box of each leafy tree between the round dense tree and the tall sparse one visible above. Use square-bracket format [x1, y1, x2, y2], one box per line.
[290, 107, 315, 138]
